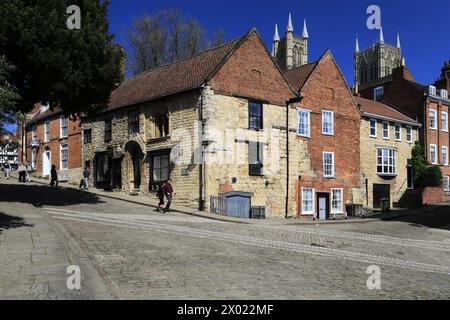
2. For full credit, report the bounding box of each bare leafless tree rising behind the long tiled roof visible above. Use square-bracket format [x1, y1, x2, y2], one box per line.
[127, 9, 225, 74]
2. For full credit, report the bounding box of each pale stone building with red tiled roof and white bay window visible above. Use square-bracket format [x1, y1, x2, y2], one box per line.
[355, 97, 420, 209]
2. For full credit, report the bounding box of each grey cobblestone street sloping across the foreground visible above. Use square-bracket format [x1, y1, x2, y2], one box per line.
[0, 181, 450, 299]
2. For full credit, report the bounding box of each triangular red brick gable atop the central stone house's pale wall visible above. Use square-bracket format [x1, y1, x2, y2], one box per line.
[210, 32, 294, 106]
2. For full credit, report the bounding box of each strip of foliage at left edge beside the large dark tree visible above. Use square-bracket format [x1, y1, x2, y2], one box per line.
[0, 56, 20, 133]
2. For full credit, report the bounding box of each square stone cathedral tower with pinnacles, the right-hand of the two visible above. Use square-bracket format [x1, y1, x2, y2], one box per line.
[354, 29, 405, 91]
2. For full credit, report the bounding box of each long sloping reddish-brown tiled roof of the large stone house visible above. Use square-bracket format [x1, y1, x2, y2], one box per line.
[107, 33, 249, 110]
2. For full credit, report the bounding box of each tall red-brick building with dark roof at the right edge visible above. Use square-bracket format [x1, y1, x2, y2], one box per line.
[359, 63, 450, 201]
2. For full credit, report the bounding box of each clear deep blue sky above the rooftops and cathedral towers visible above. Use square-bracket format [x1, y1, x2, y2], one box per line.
[4, 0, 450, 130]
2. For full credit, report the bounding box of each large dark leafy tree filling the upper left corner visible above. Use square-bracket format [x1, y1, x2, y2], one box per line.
[0, 0, 123, 114]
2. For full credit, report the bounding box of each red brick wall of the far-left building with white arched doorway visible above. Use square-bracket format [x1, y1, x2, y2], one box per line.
[27, 115, 82, 175]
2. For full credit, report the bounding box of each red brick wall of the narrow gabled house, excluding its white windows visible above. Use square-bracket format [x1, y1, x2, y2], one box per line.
[297, 55, 361, 218]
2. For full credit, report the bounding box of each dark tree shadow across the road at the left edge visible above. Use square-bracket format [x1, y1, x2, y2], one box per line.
[0, 184, 104, 207]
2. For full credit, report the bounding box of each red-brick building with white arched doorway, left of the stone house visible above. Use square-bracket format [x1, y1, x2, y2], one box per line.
[19, 103, 82, 184]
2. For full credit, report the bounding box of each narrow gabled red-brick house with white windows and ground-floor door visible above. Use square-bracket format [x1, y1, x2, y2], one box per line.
[285, 51, 363, 219]
